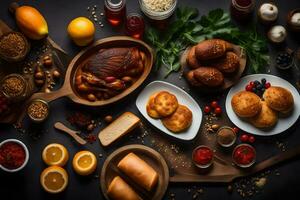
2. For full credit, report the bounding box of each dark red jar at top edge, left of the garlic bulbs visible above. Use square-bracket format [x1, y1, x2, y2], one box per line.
[230, 0, 255, 21]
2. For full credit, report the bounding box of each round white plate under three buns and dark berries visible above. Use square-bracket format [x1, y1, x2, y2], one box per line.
[225, 74, 300, 136]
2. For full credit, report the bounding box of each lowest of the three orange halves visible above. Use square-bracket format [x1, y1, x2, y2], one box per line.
[40, 166, 68, 193]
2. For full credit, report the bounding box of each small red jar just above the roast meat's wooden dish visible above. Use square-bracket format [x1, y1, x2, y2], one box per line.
[126, 13, 145, 39]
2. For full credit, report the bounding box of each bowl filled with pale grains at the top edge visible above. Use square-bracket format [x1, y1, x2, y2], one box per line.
[139, 0, 177, 20]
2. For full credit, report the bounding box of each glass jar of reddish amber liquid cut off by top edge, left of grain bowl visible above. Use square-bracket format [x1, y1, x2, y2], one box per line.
[104, 0, 126, 26]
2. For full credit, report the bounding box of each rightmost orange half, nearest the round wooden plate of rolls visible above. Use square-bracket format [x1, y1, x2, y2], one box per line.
[73, 151, 97, 176]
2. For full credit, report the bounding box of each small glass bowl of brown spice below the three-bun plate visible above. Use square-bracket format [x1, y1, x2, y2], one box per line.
[217, 126, 236, 147]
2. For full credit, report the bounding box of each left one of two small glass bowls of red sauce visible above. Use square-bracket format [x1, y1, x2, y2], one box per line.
[192, 145, 214, 169]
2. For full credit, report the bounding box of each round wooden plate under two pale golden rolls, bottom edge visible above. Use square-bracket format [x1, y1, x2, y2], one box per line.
[100, 144, 169, 200]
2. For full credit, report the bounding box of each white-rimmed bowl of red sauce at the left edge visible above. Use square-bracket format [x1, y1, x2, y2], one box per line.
[0, 139, 29, 172]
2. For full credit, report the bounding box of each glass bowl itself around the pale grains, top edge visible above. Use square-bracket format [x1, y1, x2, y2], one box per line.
[139, 0, 177, 20]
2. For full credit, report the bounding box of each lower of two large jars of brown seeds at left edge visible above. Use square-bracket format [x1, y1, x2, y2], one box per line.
[0, 74, 31, 102]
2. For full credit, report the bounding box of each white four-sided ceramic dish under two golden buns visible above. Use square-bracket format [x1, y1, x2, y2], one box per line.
[136, 81, 202, 141]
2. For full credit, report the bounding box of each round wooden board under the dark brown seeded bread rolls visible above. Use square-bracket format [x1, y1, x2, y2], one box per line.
[180, 45, 247, 93]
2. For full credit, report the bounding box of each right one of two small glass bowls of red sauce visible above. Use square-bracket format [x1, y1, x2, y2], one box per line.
[232, 144, 256, 168]
